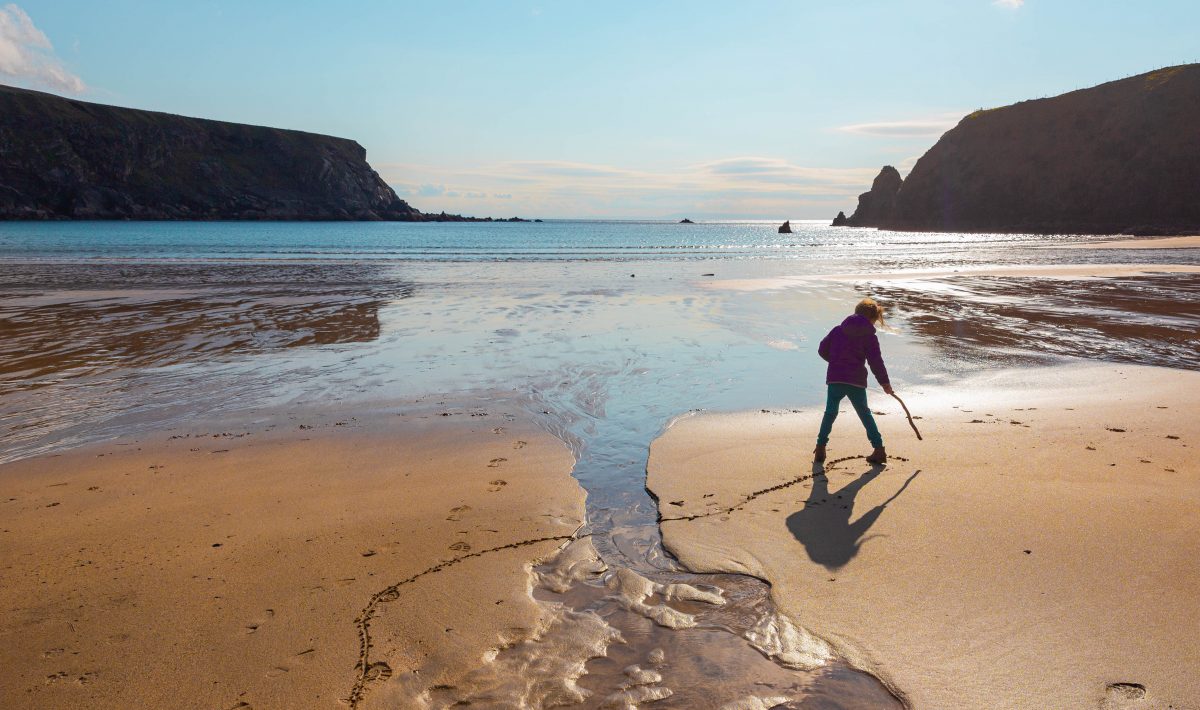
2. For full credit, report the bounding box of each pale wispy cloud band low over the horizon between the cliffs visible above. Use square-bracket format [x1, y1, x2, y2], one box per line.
[376, 156, 878, 218]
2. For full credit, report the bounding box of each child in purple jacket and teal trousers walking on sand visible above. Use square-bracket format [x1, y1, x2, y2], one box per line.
[812, 299, 892, 464]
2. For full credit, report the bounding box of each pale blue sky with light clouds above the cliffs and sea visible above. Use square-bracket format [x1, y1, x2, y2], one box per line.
[0, 0, 1200, 219]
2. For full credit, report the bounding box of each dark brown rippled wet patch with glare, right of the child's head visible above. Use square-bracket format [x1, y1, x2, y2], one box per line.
[870, 273, 1200, 369]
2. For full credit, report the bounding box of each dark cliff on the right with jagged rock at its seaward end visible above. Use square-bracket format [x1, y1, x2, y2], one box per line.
[845, 65, 1200, 234]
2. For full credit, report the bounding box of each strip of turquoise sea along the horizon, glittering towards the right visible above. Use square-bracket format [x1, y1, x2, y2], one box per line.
[0, 221, 1099, 261]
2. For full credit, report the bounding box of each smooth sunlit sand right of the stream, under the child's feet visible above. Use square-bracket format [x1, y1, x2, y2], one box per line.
[648, 363, 1200, 708]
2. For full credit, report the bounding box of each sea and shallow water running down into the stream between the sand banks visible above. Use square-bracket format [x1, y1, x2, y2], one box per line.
[0, 223, 1200, 708]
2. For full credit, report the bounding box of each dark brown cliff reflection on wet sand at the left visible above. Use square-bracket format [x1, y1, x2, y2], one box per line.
[0, 264, 413, 395]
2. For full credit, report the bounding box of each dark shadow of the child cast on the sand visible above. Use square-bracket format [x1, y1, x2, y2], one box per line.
[787, 465, 920, 572]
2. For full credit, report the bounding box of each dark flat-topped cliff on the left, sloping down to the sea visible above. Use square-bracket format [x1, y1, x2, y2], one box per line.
[0, 86, 422, 221]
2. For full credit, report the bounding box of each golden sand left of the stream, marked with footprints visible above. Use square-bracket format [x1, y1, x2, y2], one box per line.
[0, 410, 584, 709]
